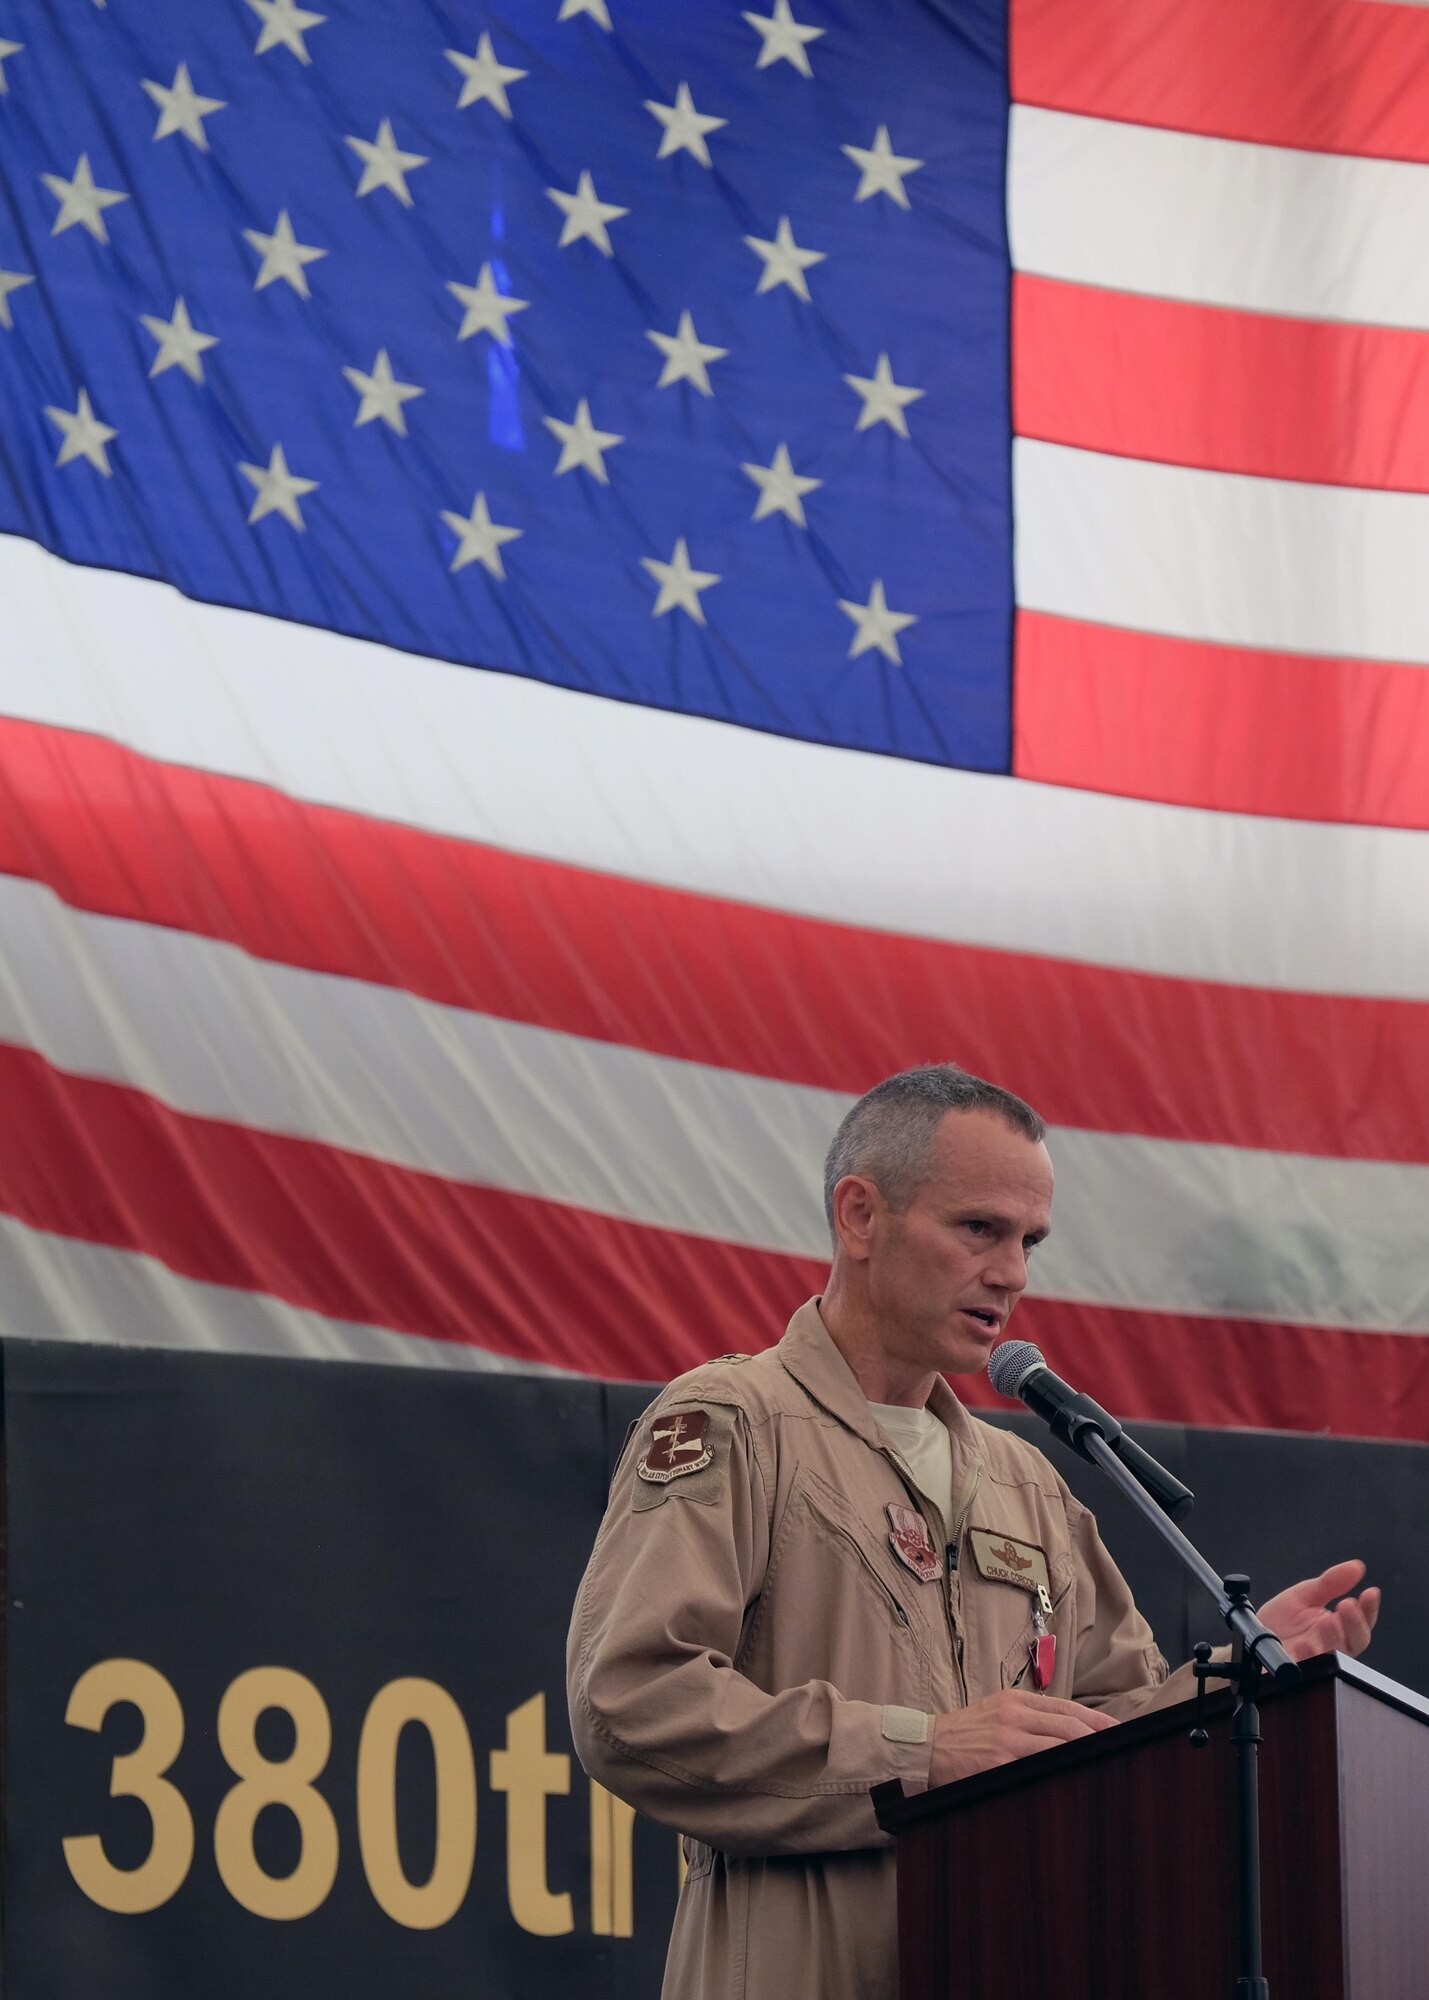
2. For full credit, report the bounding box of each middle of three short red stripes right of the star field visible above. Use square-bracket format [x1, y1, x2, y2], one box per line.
[1013, 276, 1429, 492]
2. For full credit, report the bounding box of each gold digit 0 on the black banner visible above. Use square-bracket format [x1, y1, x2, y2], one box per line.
[358, 1680, 476, 1930]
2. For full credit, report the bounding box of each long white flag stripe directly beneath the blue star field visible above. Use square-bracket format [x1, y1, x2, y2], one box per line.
[0, 522, 1429, 998]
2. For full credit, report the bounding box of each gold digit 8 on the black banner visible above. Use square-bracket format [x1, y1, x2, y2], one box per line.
[214, 1666, 338, 1922]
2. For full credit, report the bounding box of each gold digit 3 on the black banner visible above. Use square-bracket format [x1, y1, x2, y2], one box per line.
[64, 1660, 194, 1916]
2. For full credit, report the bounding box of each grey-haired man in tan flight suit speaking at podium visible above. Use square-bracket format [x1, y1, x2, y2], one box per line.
[568, 1064, 1379, 2000]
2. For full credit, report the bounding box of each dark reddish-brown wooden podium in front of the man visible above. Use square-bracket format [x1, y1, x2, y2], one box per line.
[873, 1654, 1429, 2000]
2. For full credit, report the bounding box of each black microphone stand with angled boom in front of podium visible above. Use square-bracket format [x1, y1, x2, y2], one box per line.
[1067, 1418, 1301, 2000]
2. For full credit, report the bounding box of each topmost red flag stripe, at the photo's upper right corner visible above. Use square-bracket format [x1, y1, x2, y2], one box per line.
[1011, 0, 1429, 160]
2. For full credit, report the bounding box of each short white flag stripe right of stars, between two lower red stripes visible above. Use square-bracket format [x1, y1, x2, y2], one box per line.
[1013, 438, 1429, 664]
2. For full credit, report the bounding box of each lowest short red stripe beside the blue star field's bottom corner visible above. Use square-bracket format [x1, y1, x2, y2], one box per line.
[1013, 612, 1429, 832]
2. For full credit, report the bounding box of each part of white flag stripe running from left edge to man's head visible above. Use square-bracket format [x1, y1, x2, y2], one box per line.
[0, 876, 849, 1252]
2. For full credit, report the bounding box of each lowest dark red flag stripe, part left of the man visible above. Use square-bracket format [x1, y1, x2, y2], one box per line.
[0, 1044, 823, 1380]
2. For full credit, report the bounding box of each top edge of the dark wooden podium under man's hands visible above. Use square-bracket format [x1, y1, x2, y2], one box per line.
[873, 1652, 1429, 1834]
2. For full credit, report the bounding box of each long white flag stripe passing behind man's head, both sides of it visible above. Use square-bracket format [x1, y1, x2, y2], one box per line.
[0, 880, 1429, 1330]
